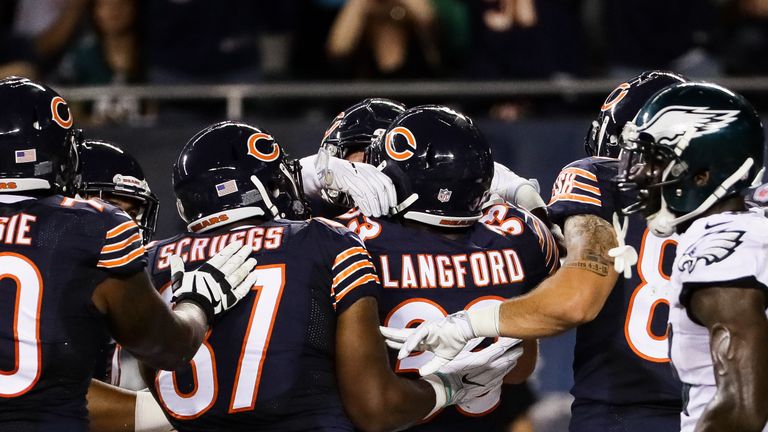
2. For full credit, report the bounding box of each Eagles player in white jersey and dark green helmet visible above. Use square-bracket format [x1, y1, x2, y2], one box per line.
[620, 83, 768, 432]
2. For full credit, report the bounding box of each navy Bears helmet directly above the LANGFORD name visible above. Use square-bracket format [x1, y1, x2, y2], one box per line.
[366, 105, 493, 228]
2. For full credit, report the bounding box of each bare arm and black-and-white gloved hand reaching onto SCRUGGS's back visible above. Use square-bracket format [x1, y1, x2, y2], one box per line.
[92, 243, 256, 370]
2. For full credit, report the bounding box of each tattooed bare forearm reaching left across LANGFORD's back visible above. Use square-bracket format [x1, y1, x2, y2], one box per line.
[499, 215, 618, 339]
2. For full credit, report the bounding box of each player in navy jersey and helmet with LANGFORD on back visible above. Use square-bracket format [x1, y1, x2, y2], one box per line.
[337, 105, 558, 431]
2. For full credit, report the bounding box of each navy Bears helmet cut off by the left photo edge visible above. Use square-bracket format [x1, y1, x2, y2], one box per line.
[0, 77, 80, 193]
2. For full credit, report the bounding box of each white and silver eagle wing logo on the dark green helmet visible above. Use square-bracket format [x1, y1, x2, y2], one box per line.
[638, 105, 740, 145]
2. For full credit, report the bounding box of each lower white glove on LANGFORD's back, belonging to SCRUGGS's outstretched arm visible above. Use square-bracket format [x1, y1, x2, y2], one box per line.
[416, 338, 523, 418]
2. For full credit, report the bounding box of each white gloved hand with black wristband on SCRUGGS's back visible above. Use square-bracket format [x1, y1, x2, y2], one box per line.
[170, 242, 256, 323]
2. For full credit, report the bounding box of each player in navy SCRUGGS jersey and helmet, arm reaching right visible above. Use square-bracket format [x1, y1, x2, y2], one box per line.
[102, 122, 519, 431]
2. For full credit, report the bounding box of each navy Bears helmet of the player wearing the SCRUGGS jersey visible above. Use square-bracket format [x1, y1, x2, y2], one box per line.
[173, 121, 309, 232]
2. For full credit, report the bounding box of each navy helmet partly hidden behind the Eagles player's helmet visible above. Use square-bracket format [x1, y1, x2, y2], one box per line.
[584, 70, 688, 158]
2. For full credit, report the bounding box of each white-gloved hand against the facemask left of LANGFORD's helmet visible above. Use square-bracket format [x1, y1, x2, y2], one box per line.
[315, 148, 397, 217]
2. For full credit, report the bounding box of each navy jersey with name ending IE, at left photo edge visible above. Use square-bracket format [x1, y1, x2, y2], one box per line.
[0, 195, 146, 431]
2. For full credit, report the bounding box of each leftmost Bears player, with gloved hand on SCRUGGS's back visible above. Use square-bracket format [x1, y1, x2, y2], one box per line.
[0, 77, 255, 431]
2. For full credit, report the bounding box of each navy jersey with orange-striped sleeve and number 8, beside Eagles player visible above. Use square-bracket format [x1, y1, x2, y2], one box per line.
[548, 157, 681, 413]
